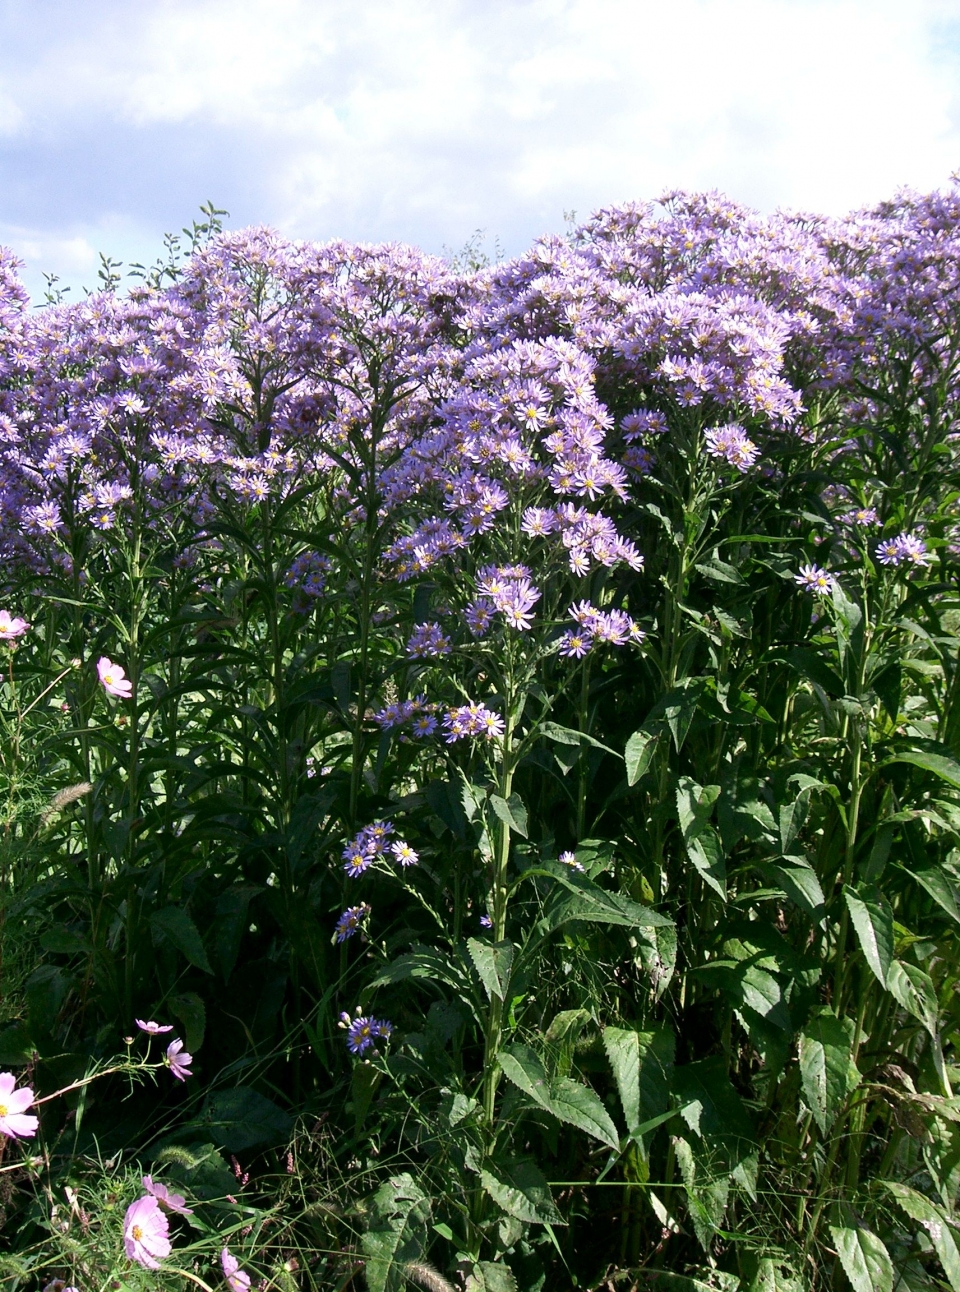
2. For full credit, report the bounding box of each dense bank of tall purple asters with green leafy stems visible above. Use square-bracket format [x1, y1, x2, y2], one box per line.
[0, 189, 960, 1292]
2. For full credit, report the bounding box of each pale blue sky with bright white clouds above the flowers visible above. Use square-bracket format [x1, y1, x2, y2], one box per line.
[0, 0, 960, 298]
